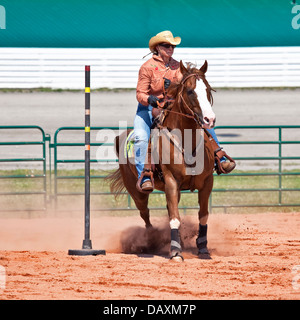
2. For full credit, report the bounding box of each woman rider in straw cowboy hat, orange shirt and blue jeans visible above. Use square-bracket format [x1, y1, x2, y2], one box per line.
[134, 31, 235, 192]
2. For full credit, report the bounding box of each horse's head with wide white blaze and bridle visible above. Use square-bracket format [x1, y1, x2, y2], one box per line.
[175, 60, 216, 129]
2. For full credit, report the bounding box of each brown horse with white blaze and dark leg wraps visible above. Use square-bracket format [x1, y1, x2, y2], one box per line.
[108, 61, 214, 260]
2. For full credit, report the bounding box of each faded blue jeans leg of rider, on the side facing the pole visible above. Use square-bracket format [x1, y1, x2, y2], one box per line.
[133, 103, 153, 182]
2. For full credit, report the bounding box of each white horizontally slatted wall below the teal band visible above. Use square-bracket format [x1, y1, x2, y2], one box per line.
[0, 47, 300, 89]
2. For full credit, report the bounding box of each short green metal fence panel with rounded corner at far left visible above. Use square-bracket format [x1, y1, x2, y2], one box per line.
[0, 126, 50, 212]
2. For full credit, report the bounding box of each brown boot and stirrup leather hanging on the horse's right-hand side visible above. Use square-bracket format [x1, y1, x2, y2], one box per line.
[204, 129, 236, 174]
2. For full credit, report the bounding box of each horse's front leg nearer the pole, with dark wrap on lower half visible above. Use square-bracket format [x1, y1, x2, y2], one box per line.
[165, 176, 183, 261]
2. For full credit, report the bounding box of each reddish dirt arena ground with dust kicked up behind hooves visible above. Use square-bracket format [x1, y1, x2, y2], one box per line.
[0, 213, 300, 300]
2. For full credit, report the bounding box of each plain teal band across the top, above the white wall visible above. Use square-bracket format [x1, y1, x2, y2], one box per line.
[0, 0, 300, 48]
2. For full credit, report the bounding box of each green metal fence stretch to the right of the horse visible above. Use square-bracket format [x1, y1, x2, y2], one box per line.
[210, 125, 300, 211]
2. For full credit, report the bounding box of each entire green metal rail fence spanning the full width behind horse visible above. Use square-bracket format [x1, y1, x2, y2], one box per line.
[0, 126, 300, 212]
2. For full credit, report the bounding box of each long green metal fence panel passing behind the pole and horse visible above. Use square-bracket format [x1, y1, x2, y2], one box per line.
[52, 126, 300, 211]
